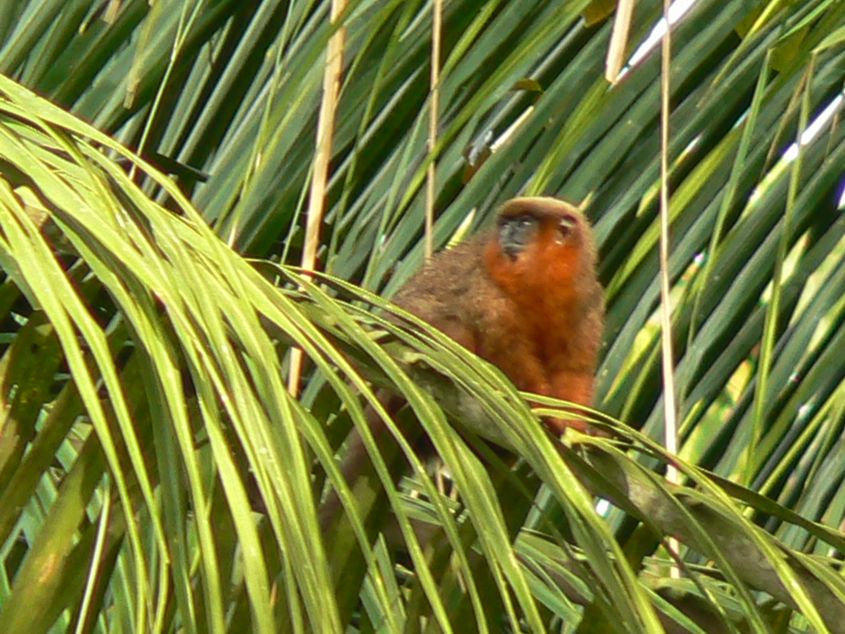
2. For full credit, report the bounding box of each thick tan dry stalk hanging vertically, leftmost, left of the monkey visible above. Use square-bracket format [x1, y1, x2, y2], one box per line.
[288, 0, 347, 396]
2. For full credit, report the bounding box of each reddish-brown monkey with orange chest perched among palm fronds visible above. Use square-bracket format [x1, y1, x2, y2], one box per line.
[321, 198, 604, 526]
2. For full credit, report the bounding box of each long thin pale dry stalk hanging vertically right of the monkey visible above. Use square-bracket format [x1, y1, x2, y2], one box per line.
[660, 0, 681, 578]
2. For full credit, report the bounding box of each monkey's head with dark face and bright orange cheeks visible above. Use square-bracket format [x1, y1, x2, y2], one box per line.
[484, 197, 596, 300]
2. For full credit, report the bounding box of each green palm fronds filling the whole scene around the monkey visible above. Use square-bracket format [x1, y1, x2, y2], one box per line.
[0, 0, 845, 632]
